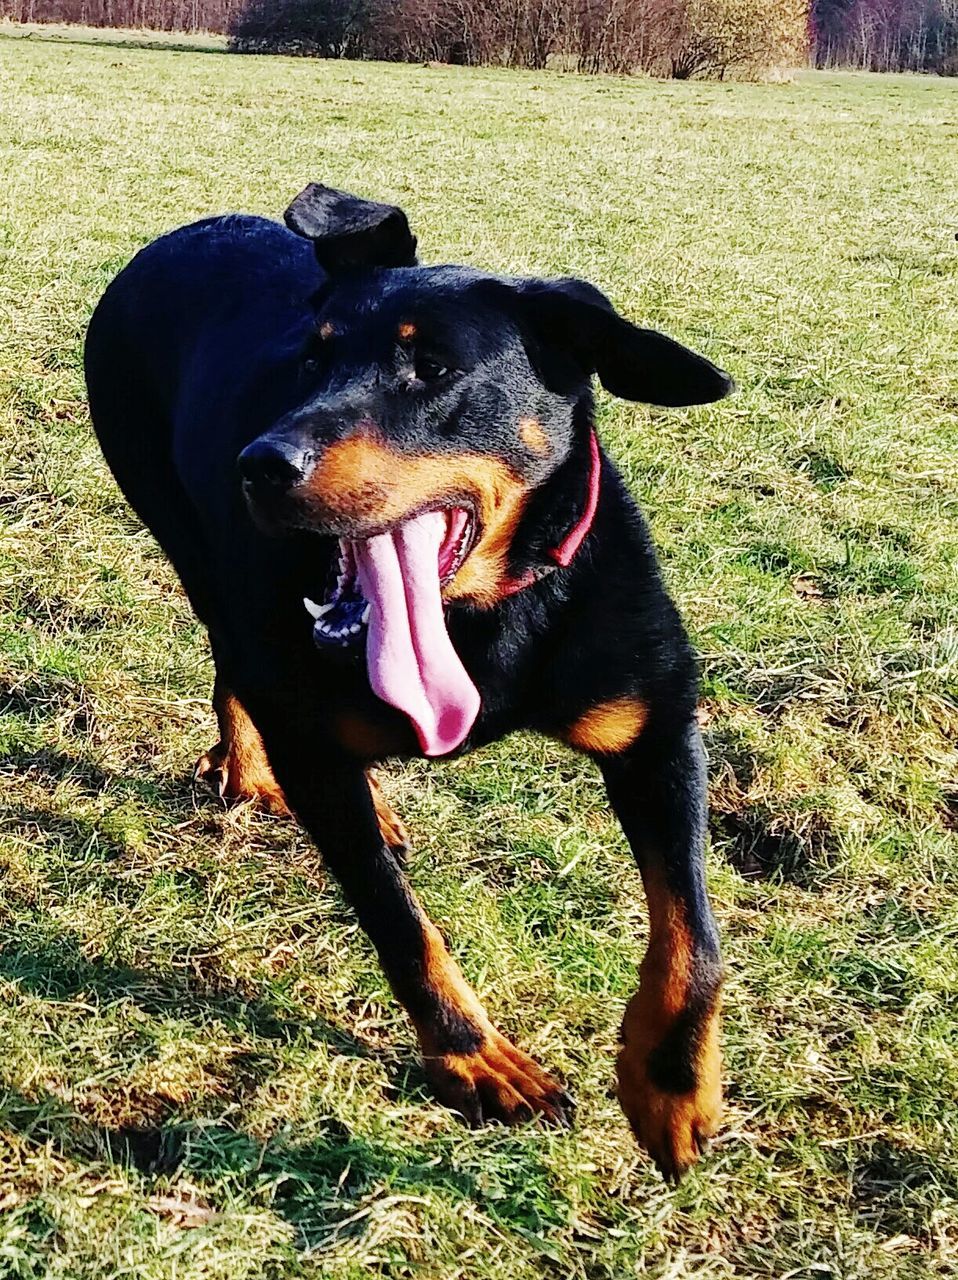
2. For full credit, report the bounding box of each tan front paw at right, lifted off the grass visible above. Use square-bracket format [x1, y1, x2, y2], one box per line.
[616, 1006, 722, 1183]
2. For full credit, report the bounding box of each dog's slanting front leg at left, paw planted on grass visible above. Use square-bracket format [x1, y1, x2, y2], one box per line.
[252, 727, 569, 1124]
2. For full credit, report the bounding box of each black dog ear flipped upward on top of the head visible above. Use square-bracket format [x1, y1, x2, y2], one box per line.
[283, 182, 416, 271]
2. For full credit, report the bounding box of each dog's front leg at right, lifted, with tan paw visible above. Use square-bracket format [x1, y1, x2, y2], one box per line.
[598, 723, 722, 1179]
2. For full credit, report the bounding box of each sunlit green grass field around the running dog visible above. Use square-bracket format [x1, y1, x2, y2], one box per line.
[0, 29, 958, 1280]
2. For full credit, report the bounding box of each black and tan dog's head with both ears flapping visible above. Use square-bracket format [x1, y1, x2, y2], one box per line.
[240, 186, 731, 752]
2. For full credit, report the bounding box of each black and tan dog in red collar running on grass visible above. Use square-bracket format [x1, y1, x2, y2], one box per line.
[86, 186, 731, 1176]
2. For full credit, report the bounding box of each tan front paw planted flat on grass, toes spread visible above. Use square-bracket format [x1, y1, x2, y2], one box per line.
[425, 1029, 574, 1125]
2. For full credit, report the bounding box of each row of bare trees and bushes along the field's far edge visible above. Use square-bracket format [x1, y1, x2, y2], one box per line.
[0, 0, 958, 78]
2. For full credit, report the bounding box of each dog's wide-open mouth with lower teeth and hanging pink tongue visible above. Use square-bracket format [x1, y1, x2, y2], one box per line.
[304, 507, 479, 755]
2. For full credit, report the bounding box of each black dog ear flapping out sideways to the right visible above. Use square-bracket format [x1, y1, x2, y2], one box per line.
[496, 278, 735, 407]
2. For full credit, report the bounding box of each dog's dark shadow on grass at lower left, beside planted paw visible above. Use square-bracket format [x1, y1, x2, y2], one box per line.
[0, 934, 566, 1252]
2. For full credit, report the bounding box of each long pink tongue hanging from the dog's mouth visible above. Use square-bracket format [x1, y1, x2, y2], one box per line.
[352, 511, 479, 755]
